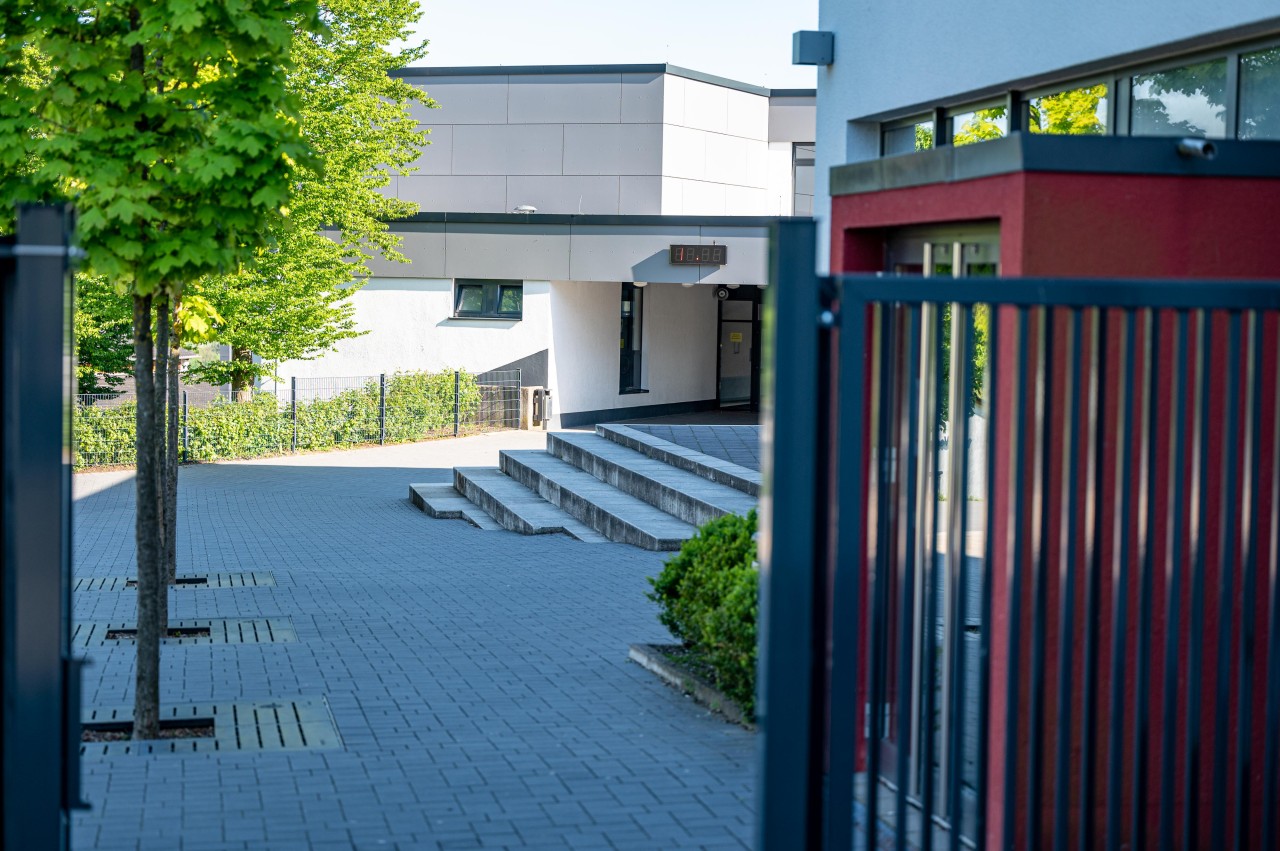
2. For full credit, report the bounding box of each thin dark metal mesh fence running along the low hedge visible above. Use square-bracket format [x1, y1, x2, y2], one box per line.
[76, 370, 521, 468]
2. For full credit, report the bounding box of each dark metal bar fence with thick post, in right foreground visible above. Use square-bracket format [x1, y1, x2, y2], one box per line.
[758, 225, 1280, 848]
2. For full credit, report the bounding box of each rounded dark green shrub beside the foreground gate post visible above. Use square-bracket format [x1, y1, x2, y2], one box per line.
[649, 511, 759, 717]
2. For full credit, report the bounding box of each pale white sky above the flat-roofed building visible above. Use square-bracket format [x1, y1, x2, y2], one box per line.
[399, 0, 818, 88]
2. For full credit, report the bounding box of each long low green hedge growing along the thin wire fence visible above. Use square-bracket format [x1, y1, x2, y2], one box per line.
[74, 372, 491, 470]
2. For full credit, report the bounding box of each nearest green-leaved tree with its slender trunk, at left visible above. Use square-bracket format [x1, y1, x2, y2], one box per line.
[0, 0, 319, 738]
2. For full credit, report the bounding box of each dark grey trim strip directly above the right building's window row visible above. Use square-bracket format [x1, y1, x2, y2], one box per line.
[851, 15, 1280, 122]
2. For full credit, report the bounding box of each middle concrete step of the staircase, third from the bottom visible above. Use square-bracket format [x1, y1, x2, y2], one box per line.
[499, 449, 698, 550]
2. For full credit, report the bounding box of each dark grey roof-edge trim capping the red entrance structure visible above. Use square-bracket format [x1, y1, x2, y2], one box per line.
[831, 133, 1280, 197]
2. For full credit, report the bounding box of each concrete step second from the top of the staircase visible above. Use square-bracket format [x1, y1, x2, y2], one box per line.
[547, 431, 756, 526]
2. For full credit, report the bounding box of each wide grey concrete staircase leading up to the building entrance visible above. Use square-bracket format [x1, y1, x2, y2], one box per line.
[410, 425, 760, 550]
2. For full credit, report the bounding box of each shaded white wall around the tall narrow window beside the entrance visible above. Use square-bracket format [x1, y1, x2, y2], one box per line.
[549, 280, 717, 425]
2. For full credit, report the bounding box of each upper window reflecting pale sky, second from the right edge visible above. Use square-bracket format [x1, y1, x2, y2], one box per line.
[1129, 59, 1226, 138]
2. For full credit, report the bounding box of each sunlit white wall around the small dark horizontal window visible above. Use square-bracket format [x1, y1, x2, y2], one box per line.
[276, 278, 552, 384]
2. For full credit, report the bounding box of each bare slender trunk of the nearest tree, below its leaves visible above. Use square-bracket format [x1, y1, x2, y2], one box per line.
[133, 296, 160, 738]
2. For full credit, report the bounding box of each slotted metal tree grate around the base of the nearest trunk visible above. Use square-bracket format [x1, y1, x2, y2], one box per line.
[81, 697, 342, 756]
